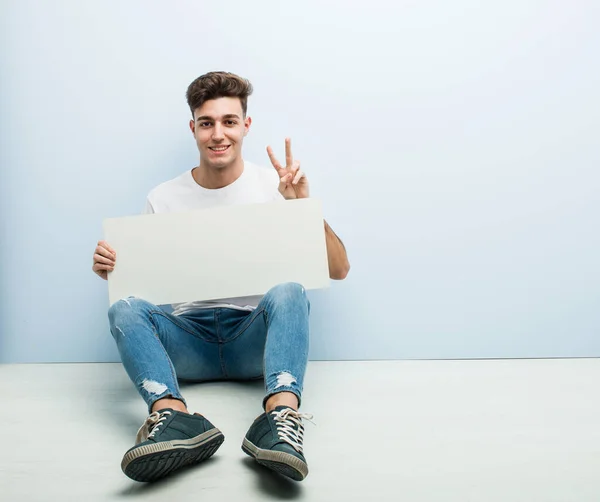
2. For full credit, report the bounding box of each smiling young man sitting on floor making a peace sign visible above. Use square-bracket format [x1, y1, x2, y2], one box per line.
[93, 72, 350, 481]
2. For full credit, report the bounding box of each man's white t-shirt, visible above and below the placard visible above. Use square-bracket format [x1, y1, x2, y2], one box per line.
[144, 162, 283, 315]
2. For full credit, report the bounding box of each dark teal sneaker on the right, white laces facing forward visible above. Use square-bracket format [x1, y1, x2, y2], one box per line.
[242, 406, 312, 481]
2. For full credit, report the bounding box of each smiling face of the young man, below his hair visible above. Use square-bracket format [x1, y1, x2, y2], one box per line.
[190, 98, 252, 169]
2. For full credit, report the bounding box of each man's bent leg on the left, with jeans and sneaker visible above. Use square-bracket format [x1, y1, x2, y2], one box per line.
[109, 298, 224, 481]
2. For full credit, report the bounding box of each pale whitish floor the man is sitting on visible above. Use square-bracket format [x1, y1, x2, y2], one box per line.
[0, 359, 600, 502]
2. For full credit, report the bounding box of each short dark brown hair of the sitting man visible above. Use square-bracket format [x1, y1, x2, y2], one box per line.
[185, 71, 253, 117]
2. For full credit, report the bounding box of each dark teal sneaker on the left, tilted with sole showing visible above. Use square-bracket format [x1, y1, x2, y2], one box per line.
[121, 408, 225, 481]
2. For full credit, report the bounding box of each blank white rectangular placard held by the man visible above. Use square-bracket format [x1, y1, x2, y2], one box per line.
[104, 199, 329, 305]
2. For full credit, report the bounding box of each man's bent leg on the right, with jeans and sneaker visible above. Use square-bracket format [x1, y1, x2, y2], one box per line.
[217, 283, 310, 480]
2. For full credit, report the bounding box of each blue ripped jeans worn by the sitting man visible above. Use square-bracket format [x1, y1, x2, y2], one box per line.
[108, 283, 310, 411]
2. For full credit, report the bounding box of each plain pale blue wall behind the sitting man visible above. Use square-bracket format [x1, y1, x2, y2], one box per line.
[0, 0, 600, 362]
